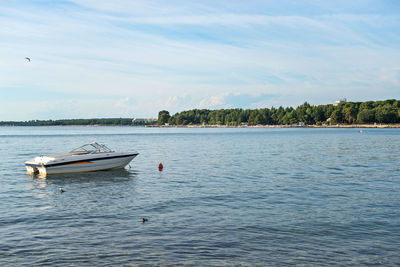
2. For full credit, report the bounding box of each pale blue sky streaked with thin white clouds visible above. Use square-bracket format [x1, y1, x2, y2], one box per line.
[0, 0, 400, 121]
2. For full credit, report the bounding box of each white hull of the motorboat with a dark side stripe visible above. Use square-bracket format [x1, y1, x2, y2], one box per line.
[25, 154, 137, 175]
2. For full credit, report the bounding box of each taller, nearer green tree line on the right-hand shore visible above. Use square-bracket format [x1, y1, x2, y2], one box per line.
[158, 99, 400, 126]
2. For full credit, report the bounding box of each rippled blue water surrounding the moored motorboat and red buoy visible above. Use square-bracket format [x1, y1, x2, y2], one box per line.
[0, 127, 400, 266]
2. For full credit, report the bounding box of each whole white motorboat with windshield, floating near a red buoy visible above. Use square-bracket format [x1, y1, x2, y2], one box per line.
[25, 142, 139, 175]
